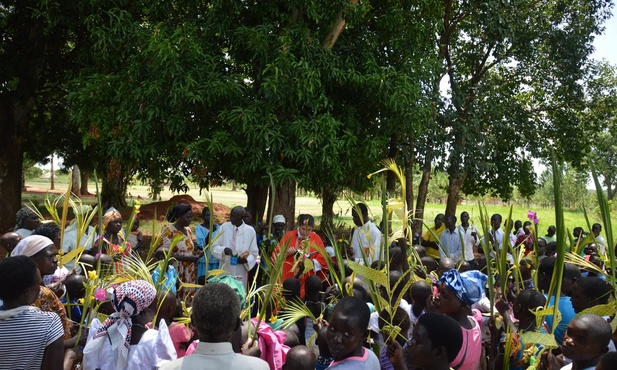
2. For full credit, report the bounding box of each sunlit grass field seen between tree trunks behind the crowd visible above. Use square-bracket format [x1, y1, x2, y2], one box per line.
[23, 177, 616, 235]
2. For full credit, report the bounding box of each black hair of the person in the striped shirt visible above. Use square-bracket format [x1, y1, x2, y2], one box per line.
[0, 256, 37, 302]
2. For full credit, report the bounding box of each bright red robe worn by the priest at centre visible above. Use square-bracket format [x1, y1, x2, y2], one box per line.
[272, 229, 328, 298]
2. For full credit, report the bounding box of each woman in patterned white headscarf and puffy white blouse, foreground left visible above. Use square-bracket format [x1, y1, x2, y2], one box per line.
[83, 280, 176, 370]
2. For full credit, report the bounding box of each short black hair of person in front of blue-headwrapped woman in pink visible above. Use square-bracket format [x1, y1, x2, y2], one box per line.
[416, 312, 463, 362]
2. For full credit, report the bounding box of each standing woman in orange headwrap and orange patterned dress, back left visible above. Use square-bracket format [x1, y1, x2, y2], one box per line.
[90, 207, 131, 274]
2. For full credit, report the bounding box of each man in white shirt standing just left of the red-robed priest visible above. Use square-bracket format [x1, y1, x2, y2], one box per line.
[212, 206, 259, 289]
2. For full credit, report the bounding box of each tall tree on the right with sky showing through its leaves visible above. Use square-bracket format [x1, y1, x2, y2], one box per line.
[438, 0, 610, 214]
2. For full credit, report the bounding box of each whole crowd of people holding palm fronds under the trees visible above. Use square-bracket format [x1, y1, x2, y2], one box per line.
[0, 203, 617, 370]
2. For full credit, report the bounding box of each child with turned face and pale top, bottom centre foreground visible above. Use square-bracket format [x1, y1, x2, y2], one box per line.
[326, 297, 379, 370]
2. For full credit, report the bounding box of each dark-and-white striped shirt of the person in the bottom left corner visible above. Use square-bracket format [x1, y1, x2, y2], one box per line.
[0, 306, 64, 369]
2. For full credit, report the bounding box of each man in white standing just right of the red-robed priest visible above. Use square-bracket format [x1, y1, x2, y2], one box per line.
[351, 203, 383, 266]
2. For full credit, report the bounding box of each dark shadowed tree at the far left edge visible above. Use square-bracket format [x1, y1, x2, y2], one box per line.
[0, 0, 89, 231]
